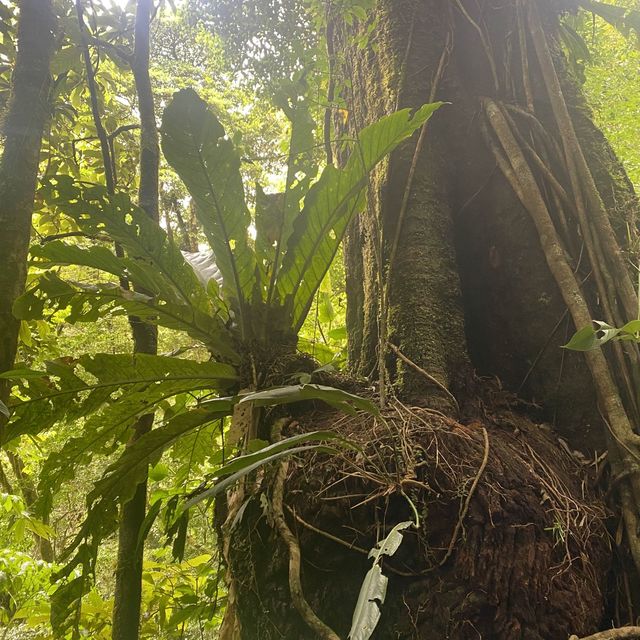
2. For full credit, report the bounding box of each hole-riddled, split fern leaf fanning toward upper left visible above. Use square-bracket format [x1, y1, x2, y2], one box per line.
[26, 175, 237, 360]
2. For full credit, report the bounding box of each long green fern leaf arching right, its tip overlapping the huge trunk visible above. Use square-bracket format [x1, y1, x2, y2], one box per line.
[277, 103, 442, 332]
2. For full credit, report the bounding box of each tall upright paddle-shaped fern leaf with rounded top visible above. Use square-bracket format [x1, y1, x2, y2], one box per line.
[161, 89, 257, 323]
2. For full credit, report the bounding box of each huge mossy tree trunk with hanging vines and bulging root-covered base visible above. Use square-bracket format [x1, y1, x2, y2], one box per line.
[222, 0, 640, 640]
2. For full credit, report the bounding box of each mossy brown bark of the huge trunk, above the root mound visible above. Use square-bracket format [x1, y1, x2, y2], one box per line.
[339, 0, 637, 450]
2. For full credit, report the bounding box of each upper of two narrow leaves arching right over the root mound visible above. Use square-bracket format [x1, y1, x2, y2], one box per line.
[240, 384, 380, 416]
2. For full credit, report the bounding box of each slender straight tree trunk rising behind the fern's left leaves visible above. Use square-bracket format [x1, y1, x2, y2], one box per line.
[112, 0, 160, 640]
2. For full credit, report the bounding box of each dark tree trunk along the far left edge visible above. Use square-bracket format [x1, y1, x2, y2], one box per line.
[0, 0, 56, 562]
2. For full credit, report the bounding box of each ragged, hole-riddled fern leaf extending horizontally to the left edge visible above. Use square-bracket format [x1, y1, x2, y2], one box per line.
[4, 354, 236, 515]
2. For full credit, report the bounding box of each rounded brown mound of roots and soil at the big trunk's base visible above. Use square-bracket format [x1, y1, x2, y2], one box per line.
[230, 403, 611, 640]
